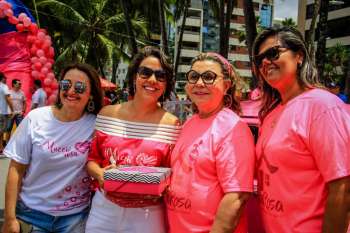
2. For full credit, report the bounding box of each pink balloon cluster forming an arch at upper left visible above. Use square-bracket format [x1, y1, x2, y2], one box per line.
[0, 0, 58, 104]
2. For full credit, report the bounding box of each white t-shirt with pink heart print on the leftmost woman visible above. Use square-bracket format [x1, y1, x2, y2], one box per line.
[4, 106, 95, 216]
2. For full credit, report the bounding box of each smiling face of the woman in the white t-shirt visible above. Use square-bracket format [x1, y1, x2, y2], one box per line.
[60, 69, 91, 112]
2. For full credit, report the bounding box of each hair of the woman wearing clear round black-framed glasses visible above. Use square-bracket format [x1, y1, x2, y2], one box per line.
[191, 52, 241, 114]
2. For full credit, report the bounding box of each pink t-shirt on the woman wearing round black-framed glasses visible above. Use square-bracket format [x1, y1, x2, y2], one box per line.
[166, 108, 254, 233]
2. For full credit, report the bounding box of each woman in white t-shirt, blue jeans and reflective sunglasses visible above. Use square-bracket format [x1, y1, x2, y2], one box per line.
[3, 64, 102, 233]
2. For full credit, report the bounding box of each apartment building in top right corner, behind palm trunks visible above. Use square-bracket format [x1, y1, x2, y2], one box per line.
[298, 0, 350, 48]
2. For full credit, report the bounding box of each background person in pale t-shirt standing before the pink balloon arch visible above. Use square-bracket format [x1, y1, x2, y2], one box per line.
[7, 79, 26, 138]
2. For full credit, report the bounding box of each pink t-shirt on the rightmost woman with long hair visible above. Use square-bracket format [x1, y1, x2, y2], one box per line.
[256, 89, 350, 233]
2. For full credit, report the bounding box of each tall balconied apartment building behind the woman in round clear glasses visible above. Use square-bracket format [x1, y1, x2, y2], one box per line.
[175, 0, 273, 93]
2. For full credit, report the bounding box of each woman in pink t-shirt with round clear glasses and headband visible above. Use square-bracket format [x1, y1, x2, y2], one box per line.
[166, 53, 254, 233]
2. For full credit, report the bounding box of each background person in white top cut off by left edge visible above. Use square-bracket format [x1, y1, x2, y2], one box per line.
[0, 72, 13, 154]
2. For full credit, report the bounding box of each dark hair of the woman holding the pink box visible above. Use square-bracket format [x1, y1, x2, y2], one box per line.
[127, 46, 175, 102]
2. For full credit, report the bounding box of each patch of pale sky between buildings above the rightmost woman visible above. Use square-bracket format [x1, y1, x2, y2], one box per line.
[273, 0, 298, 22]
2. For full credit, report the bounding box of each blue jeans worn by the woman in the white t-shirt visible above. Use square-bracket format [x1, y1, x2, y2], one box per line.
[16, 200, 89, 233]
